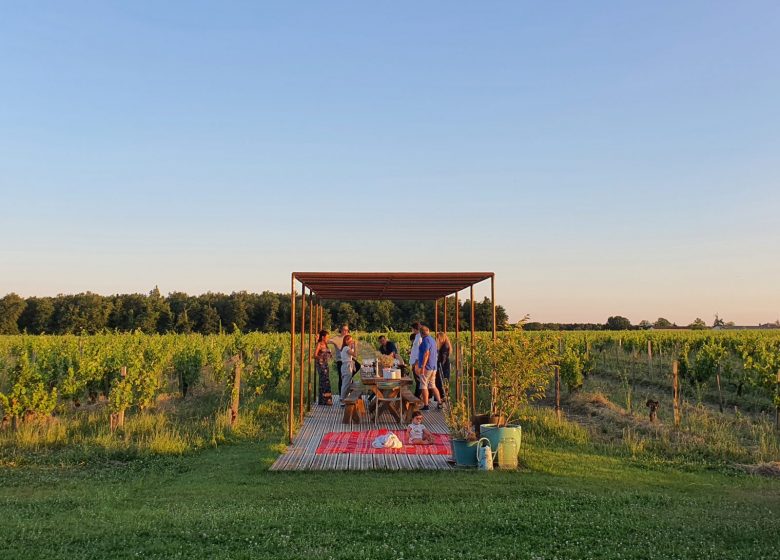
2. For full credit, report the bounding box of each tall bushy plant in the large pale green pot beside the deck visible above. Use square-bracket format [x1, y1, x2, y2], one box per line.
[478, 334, 555, 462]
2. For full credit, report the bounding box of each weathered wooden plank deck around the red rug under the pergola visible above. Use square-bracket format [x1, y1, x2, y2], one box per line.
[271, 397, 452, 471]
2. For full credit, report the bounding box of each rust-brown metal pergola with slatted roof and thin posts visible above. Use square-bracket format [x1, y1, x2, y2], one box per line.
[288, 272, 496, 441]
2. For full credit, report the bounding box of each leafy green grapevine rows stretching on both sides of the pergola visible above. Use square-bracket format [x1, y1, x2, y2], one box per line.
[0, 331, 780, 468]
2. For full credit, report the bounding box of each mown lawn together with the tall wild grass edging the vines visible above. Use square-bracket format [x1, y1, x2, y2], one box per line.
[0, 379, 780, 560]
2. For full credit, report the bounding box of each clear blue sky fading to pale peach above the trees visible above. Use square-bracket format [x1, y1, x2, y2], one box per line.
[0, 0, 780, 325]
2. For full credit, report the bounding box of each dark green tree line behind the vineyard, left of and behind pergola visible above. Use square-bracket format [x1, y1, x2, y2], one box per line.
[0, 288, 509, 334]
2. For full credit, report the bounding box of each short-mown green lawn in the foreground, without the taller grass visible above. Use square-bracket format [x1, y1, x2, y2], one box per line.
[0, 442, 780, 560]
